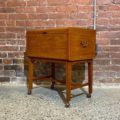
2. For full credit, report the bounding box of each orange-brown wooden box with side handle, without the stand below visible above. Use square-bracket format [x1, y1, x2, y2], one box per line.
[27, 28, 96, 61]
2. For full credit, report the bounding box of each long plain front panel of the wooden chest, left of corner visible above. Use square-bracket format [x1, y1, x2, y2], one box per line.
[27, 32, 67, 59]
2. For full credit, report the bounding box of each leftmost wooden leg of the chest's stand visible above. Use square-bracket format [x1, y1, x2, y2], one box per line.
[28, 58, 33, 94]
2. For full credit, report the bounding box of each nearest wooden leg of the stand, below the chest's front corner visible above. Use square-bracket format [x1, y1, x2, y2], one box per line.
[65, 62, 72, 107]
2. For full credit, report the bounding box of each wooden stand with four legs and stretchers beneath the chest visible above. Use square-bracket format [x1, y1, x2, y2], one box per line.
[27, 57, 93, 107]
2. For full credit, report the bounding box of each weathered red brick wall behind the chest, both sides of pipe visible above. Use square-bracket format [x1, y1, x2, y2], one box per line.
[0, 0, 120, 84]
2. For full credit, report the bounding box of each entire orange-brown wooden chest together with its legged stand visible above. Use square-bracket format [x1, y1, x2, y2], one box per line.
[26, 27, 96, 106]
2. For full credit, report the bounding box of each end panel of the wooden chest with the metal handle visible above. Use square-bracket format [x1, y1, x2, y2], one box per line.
[69, 29, 96, 60]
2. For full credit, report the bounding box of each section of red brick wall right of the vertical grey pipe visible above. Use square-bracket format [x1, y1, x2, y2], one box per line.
[94, 0, 120, 84]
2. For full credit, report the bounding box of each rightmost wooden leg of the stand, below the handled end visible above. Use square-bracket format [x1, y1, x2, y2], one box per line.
[87, 61, 93, 97]
